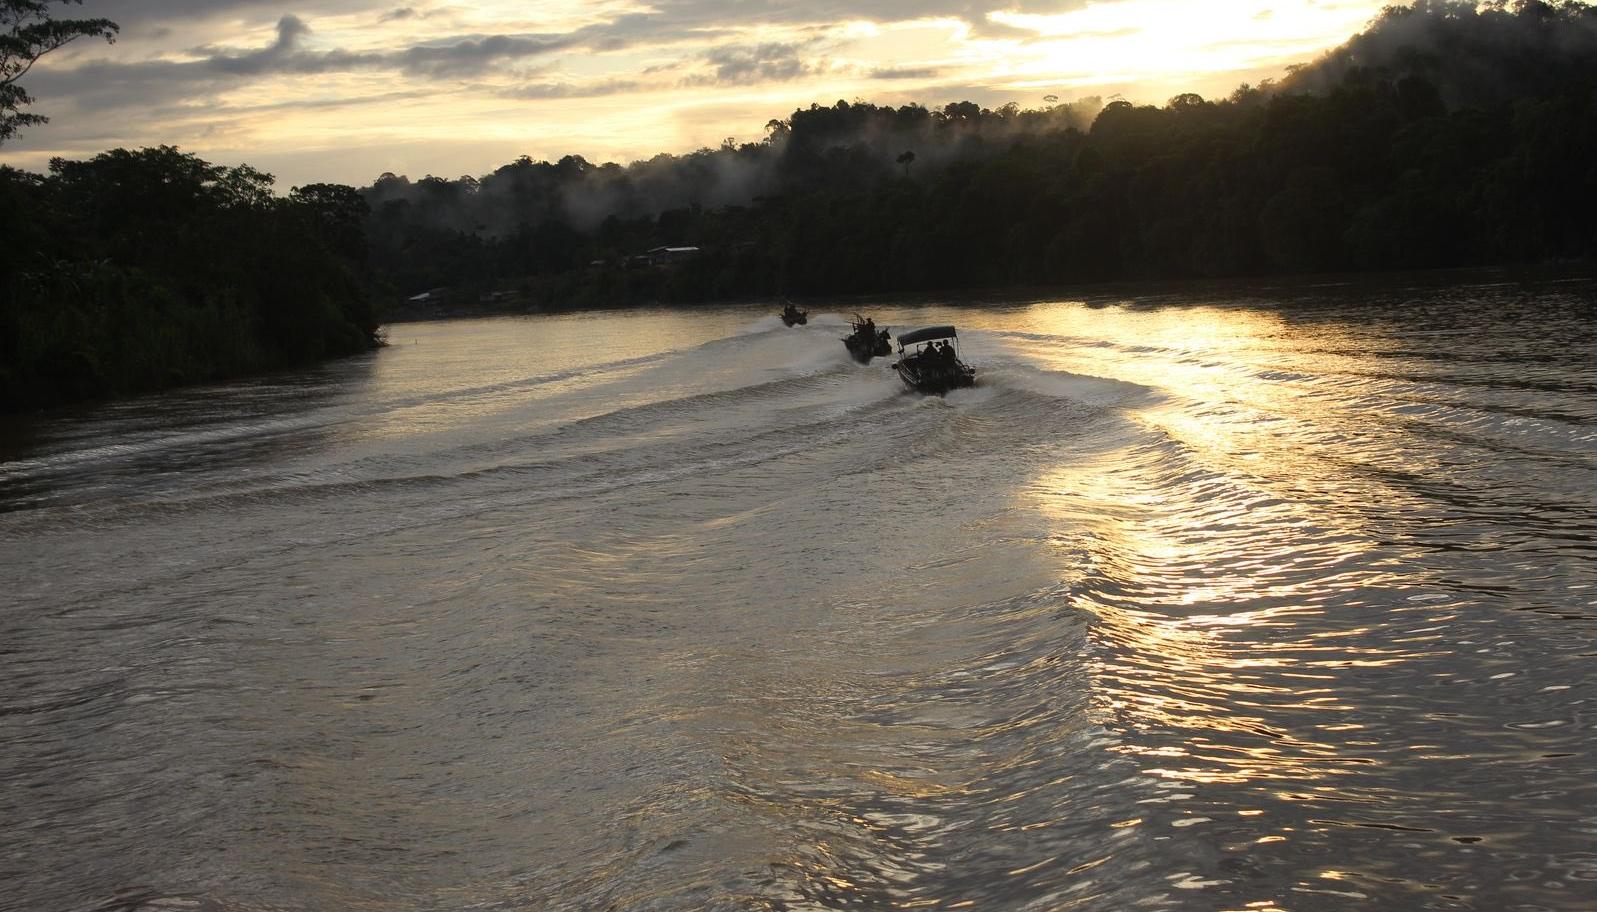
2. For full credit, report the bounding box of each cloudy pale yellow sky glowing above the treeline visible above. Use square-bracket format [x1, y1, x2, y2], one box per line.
[0, 0, 1385, 190]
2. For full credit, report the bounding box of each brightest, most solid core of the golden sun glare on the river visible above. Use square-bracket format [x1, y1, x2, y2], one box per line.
[1027, 305, 1434, 789]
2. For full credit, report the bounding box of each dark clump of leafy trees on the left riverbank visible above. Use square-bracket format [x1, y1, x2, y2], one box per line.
[0, 147, 377, 409]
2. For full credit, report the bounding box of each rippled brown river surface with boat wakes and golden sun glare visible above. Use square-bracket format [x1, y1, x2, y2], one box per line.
[0, 283, 1597, 912]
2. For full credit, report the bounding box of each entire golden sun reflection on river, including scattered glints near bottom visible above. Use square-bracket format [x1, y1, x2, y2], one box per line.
[983, 285, 1583, 910]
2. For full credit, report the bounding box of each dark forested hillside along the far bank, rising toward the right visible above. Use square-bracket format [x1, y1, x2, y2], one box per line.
[364, 0, 1597, 307]
